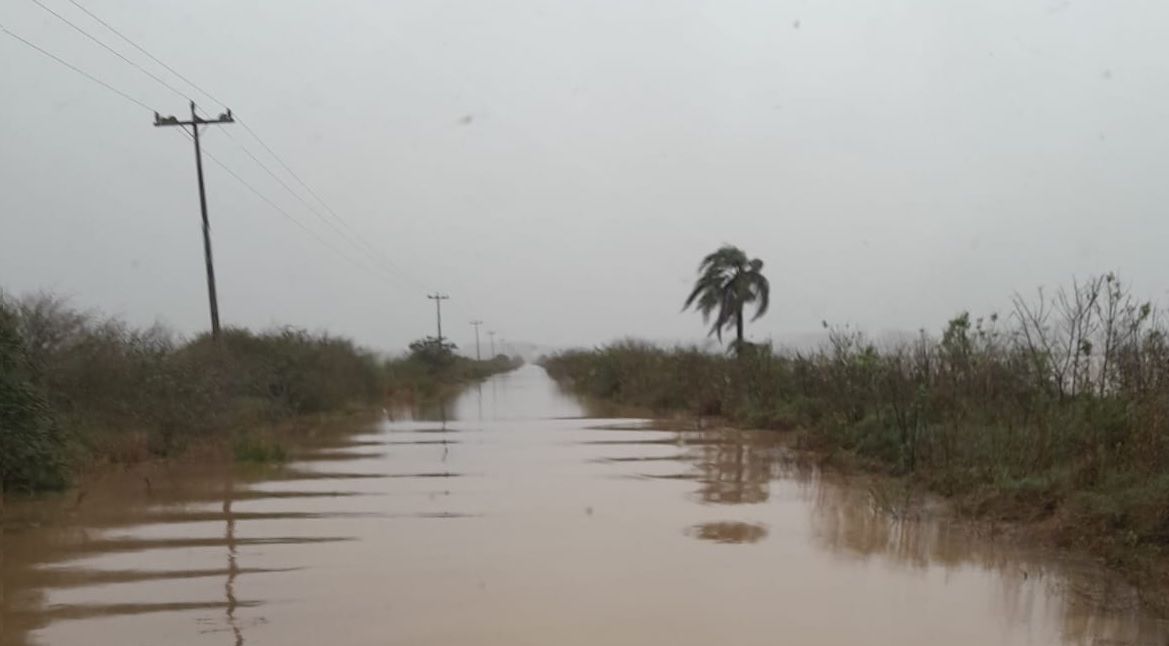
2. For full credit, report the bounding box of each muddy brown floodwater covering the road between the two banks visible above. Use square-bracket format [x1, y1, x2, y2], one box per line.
[0, 367, 1169, 646]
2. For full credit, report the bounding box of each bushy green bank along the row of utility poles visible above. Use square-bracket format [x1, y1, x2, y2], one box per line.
[0, 289, 514, 492]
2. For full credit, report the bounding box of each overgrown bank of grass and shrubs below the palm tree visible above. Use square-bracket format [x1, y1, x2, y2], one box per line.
[542, 276, 1169, 577]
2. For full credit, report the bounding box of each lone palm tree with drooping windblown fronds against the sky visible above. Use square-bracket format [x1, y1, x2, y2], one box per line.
[682, 244, 772, 346]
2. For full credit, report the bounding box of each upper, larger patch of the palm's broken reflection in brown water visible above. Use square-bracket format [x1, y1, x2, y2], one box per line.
[698, 433, 773, 505]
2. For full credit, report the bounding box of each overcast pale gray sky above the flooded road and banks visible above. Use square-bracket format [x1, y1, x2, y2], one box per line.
[0, 0, 1169, 349]
